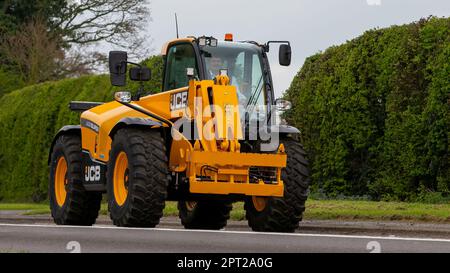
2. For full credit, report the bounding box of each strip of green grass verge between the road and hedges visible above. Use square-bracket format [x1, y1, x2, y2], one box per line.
[0, 200, 450, 222]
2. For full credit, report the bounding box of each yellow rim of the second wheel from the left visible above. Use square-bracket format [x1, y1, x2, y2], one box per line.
[113, 152, 128, 206]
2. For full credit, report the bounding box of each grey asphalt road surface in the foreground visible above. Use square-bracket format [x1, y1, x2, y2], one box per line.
[0, 224, 450, 253]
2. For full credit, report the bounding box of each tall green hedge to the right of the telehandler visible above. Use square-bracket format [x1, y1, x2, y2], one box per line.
[285, 18, 450, 200]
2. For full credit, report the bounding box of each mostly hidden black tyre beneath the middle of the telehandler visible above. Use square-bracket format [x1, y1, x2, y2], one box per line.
[178, 200, 233, 230]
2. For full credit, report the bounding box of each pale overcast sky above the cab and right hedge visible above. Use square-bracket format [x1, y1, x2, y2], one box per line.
[148, 0, 450, 96]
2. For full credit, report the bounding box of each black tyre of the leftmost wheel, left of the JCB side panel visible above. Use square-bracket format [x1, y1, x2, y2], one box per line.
[49, 135, 102, 226]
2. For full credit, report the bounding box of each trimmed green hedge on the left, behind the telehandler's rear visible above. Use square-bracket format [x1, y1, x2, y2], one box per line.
[0, 56, 162, 201]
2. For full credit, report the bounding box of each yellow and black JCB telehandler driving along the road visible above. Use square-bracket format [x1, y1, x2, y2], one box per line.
[49, 35, 309, 232]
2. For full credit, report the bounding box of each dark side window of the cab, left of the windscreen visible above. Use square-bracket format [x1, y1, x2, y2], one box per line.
[164, 44, 198, 91]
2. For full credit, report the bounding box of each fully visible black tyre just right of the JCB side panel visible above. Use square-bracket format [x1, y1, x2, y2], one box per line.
[107, 128, 169, 227]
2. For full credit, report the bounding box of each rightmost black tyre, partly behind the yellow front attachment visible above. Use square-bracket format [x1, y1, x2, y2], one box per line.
[245, 139, 309, 232]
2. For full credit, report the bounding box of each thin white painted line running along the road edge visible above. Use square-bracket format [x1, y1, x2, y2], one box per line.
[0, 223, 450, 243]
